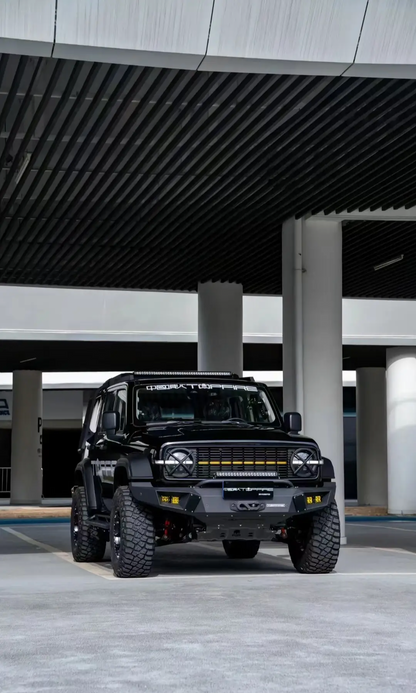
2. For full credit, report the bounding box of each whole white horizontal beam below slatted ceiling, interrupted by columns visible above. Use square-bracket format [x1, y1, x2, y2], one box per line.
[0, 286, 416, 346]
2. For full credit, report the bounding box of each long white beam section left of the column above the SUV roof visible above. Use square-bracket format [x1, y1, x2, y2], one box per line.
[0, 286, 198, 341]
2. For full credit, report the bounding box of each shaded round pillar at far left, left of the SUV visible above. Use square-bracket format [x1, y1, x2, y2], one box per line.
[10, 371, 42, 505]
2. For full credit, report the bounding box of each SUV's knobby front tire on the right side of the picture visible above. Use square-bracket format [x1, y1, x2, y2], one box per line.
[288, 501, 341, 573]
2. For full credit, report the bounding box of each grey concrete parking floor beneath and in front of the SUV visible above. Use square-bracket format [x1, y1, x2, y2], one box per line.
[0, 522, 416, 693]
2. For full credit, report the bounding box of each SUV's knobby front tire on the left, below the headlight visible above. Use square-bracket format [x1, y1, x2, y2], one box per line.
[110, 486, 156, 578]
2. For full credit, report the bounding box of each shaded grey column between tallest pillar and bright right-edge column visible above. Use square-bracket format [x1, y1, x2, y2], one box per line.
[357, 368, 387, 507]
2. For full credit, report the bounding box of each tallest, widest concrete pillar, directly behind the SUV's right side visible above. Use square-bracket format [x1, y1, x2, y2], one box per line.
[282, 219, 345, 538]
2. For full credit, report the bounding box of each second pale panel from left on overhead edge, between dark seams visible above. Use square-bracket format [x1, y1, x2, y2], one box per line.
[53, 0, 213, 70]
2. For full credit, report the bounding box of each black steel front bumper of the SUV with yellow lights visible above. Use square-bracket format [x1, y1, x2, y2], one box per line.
[130, 479, 335, 540]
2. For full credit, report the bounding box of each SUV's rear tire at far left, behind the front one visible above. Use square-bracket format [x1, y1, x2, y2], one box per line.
[71, 486, 107, 563]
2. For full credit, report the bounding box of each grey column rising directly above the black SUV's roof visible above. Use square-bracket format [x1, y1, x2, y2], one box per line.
[198, 282, 243, 375]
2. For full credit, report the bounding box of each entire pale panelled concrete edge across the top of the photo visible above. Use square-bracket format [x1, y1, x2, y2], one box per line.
[0, 0, 416, 79]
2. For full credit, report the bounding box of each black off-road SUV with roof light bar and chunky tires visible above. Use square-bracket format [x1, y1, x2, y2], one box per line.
[71, 372, 340, 577]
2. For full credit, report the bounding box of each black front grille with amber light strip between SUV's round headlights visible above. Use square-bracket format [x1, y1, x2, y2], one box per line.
[164, 445, 289, 479]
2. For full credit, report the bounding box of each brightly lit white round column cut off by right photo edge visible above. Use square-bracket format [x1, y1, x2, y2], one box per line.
[387, 347, 416, 515]
